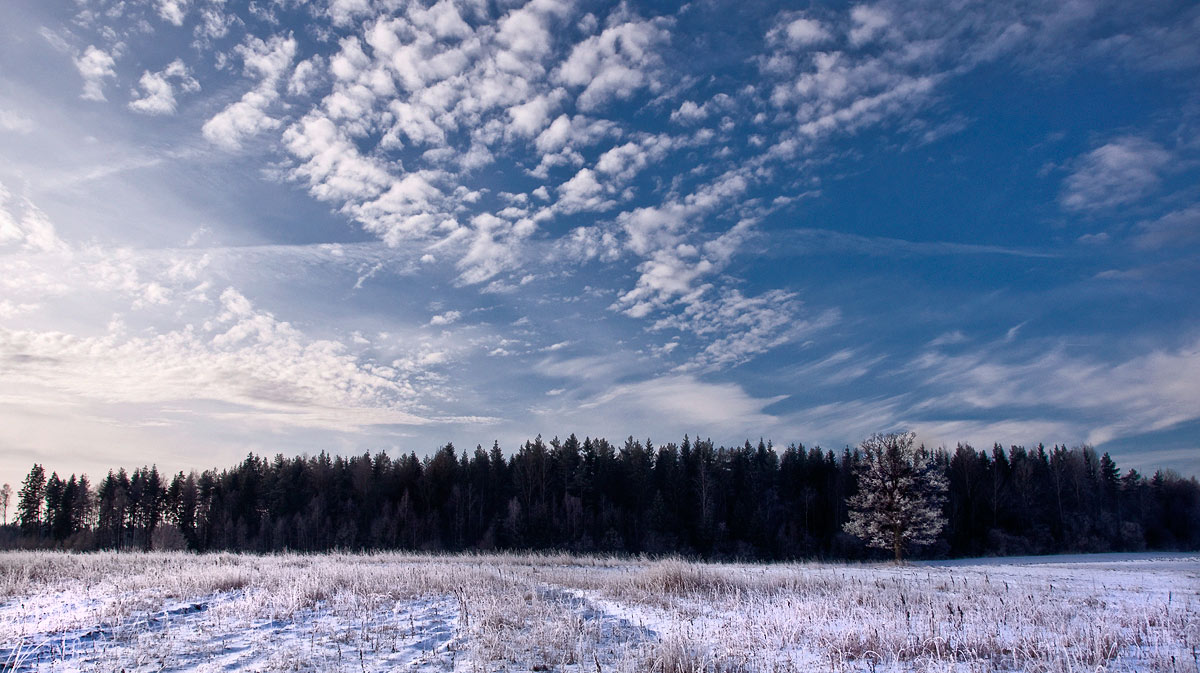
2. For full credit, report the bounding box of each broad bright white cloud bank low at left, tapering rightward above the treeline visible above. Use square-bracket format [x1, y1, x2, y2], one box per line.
[0, 289, 427, 431]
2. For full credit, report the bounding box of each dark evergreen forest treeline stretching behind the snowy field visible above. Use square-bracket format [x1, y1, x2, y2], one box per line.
[0, 434, 1200, 559]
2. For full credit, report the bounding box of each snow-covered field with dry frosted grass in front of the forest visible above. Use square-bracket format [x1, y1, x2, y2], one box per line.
[0, 553, 1200, 673]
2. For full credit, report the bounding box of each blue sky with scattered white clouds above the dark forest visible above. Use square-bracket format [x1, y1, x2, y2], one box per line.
[0, 0, 1200, 486]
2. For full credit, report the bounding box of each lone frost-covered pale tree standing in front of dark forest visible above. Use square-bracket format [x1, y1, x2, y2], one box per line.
[846, 432, 946, 563]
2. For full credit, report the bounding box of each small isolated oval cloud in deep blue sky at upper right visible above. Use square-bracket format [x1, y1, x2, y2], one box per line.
[1058, 136, 1171, 211]
